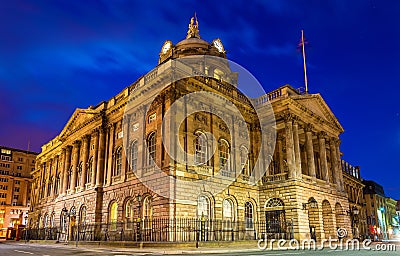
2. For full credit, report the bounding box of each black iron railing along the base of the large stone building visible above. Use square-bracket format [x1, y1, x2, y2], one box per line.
[26, 219, 293, 242]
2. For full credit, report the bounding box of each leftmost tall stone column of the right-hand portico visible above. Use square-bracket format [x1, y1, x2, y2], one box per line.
[284, 114, 296, 178]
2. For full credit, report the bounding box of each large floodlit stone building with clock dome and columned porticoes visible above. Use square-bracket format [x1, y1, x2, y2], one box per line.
[29, 19, 353, 241]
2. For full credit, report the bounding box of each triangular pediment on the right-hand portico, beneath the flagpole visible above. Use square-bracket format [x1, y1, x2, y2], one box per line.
[291, 93, 343, 132]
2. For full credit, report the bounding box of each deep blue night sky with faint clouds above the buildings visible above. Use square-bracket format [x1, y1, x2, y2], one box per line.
[0, 0, 400, 199]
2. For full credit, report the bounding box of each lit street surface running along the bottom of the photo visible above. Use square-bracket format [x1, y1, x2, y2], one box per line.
[0, 241, 400, 256]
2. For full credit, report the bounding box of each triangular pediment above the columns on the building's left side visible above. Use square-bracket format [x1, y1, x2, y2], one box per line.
[59, 108, 100, 137]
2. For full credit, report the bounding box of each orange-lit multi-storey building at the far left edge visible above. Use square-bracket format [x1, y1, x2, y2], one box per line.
[0, 146, 38, 238]
